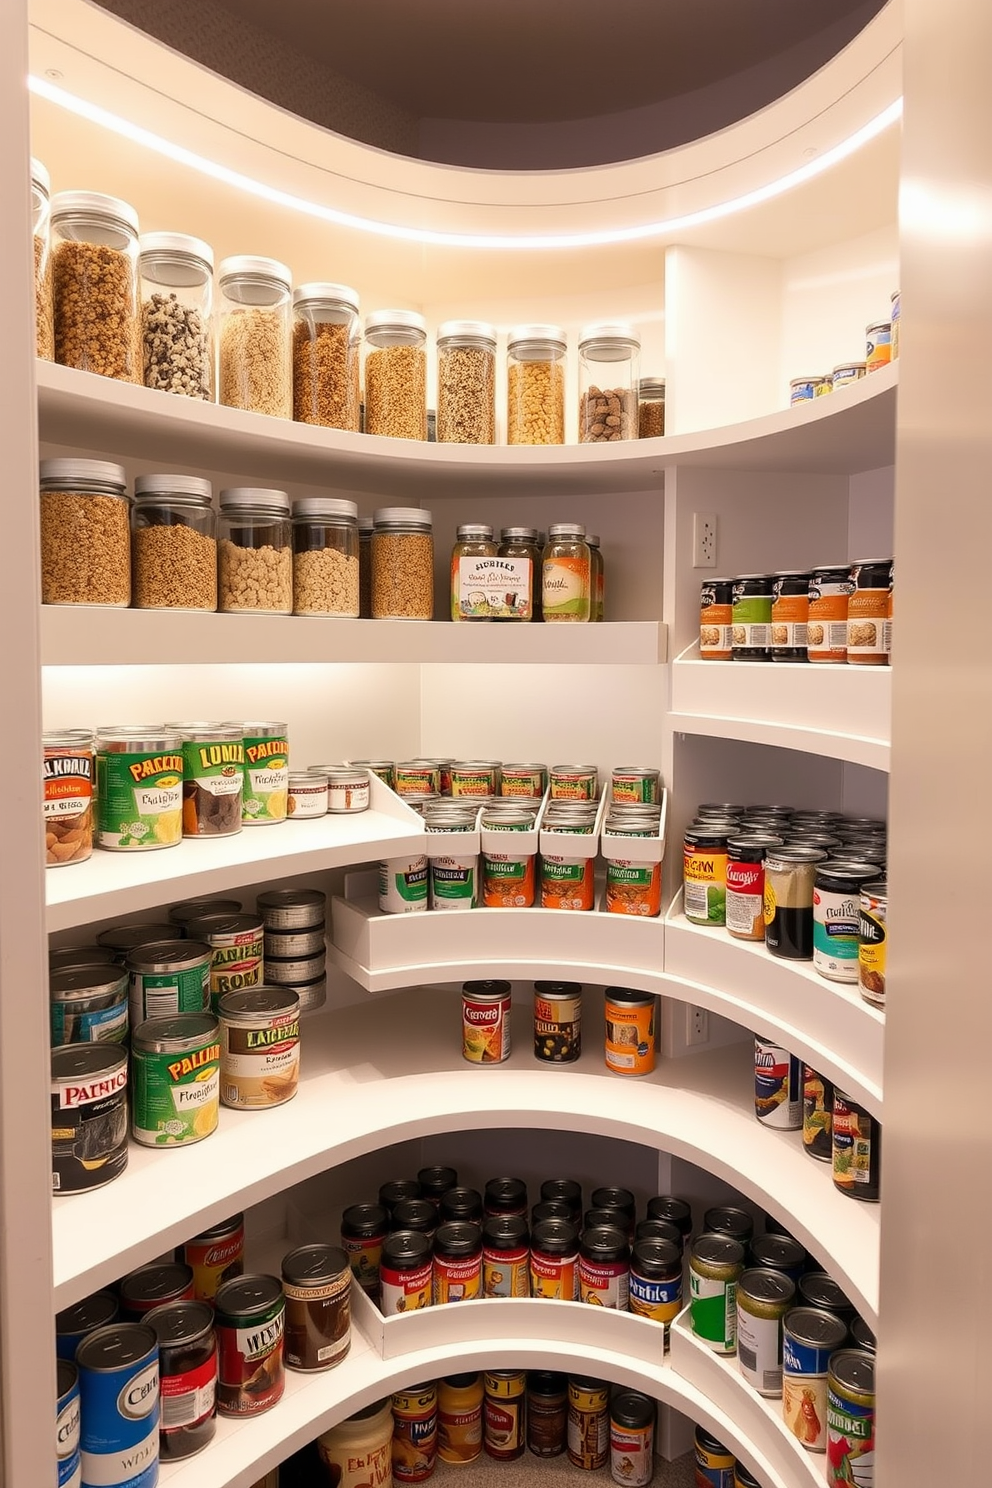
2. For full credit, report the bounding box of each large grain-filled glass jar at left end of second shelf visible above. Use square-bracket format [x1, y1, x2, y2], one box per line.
[39, 458, 131, 609]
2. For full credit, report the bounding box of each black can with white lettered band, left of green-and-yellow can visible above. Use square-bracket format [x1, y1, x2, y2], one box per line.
[52, 1043, 128, 1193]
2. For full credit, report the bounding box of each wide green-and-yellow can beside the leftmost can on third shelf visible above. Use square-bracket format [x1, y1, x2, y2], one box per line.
[97, 723, 183, 853]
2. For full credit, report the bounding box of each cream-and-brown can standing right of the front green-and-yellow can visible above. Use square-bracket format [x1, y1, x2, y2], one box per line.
[219, 987, 299, 1110]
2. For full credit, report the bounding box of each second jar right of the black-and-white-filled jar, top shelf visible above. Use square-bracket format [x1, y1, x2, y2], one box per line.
[293, 284, 361, 434]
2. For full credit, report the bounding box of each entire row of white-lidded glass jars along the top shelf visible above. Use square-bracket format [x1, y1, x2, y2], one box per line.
[31, 161, 665, 445]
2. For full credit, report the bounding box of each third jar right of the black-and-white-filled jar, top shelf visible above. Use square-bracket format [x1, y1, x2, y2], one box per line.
[364, 310, 427, 440]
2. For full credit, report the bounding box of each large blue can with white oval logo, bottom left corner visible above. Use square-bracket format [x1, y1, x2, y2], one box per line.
[76, 1323, 159, 1488]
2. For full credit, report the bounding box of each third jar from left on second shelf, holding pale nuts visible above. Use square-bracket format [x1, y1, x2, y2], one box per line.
[217, 487, 293, 615]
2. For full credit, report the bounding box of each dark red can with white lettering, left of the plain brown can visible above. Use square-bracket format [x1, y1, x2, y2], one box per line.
[214, 1275, 286, 1417]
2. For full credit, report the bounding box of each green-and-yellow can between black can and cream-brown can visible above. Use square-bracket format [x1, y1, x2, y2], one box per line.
[131, 1013, 220, 1147]
